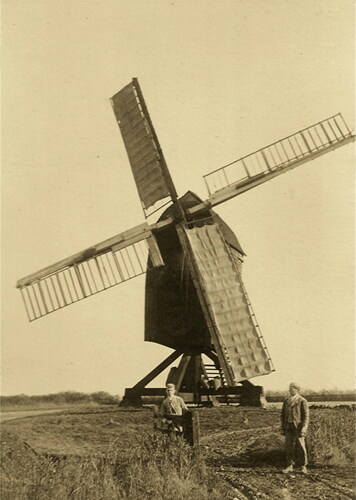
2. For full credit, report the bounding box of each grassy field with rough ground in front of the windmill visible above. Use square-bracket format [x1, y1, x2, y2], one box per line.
[1, 406, 355, 500]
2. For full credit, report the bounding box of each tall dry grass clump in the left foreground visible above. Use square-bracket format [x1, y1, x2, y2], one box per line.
[2, 433, 225, 500]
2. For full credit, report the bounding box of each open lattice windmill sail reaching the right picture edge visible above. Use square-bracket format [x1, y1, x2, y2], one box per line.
[188, 113, 355, 214]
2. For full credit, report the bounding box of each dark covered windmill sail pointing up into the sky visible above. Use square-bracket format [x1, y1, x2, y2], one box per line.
[111, 78, 177, 217]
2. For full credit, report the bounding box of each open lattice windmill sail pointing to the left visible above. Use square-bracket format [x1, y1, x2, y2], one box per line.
[16, 221, 171, 321]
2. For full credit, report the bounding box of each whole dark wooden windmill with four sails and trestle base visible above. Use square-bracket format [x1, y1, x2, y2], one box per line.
[17, 78, 355, 404]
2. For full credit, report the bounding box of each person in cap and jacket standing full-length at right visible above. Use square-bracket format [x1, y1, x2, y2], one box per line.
[281, 382, 309, 474]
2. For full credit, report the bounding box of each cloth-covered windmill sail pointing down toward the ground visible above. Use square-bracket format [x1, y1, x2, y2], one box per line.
[186, 224, 273, 382]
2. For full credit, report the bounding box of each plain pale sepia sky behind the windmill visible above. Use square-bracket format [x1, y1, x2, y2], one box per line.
[1, 0, 356, 395]
